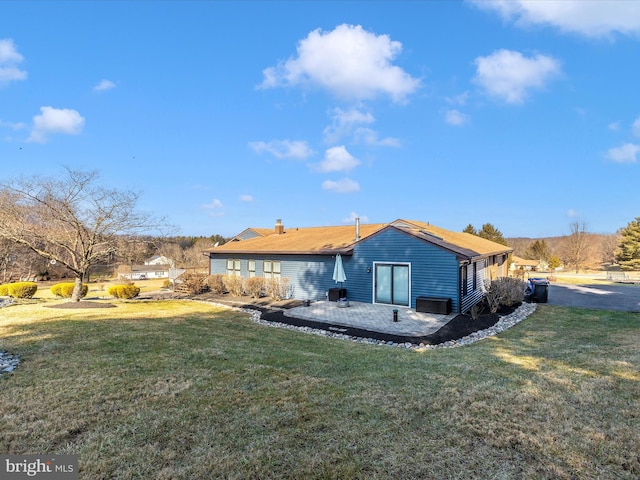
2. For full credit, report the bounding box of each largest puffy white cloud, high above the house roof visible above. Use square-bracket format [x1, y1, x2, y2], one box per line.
[261, 24, 420, 102]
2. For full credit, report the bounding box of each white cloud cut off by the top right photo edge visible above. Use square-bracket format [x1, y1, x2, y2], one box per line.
[472, 0, 640, 37]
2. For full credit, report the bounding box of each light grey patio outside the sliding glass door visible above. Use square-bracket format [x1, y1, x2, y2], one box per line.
[284, 300, 457, 337]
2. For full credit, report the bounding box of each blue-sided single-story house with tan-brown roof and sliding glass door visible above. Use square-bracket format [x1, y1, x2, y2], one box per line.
[207, 220, 511, 313]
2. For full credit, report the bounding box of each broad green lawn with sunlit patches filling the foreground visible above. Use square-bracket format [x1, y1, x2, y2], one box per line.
[0, 301, 640, 479]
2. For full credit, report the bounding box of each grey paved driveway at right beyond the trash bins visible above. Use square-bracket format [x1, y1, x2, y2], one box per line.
[548, 283, 640, 312]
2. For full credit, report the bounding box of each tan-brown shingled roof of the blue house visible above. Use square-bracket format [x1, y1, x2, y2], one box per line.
[206, 220, 511, 259]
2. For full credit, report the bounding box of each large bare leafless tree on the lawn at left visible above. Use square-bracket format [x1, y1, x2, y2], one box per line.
[0, 168, 168, 301]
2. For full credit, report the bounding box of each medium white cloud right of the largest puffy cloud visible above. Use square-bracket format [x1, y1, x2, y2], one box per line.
[474, 49, 561, 104]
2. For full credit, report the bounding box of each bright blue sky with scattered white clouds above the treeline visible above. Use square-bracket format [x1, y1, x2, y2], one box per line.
[0, 0, 640, 237]
